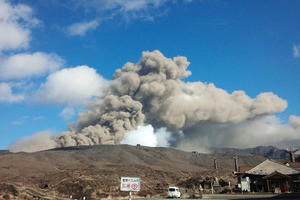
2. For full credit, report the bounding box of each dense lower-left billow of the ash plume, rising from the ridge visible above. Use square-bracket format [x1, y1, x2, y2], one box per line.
[56, 94, 145, 147]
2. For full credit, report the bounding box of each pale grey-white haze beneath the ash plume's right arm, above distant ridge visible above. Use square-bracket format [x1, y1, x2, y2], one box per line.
[179, 115, 300, 150]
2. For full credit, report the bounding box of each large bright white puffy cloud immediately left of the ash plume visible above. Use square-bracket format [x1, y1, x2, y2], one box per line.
[34, 66, 108, 105]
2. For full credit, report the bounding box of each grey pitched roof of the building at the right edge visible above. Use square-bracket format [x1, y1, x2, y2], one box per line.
[245, 160, 300, 175]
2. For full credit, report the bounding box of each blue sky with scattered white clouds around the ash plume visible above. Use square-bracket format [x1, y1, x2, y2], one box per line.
[0, 0, 300, 149]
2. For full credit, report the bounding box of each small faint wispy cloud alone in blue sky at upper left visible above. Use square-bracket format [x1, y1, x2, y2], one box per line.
[68, 20, 99, 36]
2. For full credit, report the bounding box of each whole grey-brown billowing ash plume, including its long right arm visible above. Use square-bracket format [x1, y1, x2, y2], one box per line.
[56, 51, 287, 146]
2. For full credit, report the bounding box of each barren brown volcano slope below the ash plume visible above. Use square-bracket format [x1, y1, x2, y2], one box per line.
[0, 145, 265, 199]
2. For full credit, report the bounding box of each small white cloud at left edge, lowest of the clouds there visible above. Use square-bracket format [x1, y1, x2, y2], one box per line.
[0, 83, 25, 103]
